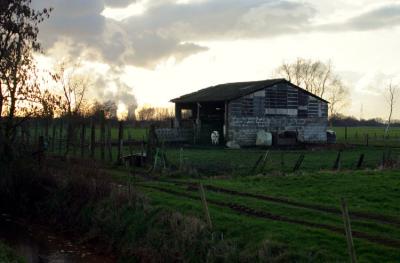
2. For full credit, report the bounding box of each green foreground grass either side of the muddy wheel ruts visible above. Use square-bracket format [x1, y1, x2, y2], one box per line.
[132, 171, 400, 262]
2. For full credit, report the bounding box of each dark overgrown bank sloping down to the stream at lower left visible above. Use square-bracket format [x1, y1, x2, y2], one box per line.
[0, 159, 308, 262]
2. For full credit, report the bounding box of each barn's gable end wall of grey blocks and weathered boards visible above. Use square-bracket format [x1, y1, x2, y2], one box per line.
[228, 83, 328, 145]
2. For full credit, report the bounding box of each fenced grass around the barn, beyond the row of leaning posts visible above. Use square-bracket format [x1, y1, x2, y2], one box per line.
[26, 126, 400, 175]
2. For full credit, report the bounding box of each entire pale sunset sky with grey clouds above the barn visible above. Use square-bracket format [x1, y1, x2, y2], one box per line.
[32, 0, 400, 119]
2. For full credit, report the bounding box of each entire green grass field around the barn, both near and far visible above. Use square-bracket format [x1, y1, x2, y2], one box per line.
[22, 123, 400, 262]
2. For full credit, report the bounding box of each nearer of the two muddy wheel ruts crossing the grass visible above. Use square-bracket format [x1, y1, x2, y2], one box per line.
[138, 184, 400, 249]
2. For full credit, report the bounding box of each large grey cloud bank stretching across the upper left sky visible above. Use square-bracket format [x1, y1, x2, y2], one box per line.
[35, 0, 315, 68]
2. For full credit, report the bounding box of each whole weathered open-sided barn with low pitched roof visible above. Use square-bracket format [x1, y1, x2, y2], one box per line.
[171, 79, 328, 146]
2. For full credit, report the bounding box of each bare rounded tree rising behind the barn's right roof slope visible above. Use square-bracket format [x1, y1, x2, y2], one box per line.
[276, 58, 349, 116]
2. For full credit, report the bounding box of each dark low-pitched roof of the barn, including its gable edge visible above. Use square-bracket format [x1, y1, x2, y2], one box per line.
[171, 79, 327, 103]
